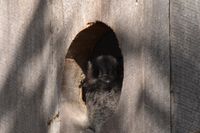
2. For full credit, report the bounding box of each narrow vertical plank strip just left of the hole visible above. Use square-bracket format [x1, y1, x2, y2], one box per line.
[48, 0, 66, 133]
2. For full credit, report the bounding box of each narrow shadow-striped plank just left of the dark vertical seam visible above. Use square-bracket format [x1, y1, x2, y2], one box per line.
[142, 0, 170, 133]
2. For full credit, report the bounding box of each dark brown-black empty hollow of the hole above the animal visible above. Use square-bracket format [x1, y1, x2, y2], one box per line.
[66, 21, 124, 101]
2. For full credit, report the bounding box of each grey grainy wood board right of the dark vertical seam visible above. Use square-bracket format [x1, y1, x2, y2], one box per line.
[170, 0, 200, 133]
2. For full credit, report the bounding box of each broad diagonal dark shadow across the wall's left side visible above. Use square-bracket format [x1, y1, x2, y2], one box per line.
[0, 0, 49, 133]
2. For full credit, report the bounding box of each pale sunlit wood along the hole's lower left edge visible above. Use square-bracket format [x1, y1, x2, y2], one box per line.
[60, 58, 87, 133]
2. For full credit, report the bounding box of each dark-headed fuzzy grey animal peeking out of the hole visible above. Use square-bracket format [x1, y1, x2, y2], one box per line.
[83, 55, 121, 133]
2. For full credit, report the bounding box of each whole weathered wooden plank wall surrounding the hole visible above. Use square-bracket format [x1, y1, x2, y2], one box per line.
[0, 0, 200, 133]
